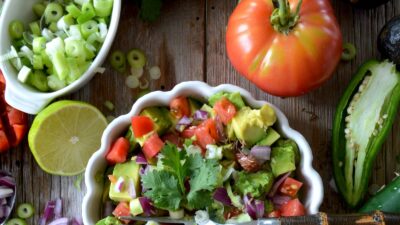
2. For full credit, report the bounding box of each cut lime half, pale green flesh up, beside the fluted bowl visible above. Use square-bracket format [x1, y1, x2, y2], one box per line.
[28, 100, 107, 176]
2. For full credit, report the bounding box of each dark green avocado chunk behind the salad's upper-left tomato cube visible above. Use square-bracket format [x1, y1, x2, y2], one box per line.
[140, 106, 172, 136]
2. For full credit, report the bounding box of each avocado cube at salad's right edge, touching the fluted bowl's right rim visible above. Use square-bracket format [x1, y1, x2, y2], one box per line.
[271, 141, 298, 177]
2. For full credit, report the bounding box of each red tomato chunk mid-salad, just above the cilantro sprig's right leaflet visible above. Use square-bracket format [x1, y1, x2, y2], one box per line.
[195, 119, 218, 149]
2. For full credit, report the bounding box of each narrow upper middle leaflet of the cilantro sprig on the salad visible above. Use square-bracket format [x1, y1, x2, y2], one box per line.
[161, 142, 188, 193]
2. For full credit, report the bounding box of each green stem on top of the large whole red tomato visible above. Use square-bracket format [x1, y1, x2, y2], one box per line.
[270, 0, 303, 35]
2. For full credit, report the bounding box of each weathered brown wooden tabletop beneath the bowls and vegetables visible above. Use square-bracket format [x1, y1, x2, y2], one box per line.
[0, 0, 400, 224]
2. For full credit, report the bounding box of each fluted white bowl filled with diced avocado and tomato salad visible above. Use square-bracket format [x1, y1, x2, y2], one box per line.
[83, 82, 322, 225]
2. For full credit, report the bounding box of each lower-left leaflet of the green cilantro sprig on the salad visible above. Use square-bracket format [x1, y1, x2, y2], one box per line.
[142, 170, 183, 210]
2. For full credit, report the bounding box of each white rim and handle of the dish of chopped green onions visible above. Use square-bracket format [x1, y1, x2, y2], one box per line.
[0, 0, 121, 114]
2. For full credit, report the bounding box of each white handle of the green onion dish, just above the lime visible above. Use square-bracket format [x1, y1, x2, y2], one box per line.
[4, 86, 53, 115]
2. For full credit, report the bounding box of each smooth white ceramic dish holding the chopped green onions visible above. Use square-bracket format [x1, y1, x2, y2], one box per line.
[0, 0, 121, 114]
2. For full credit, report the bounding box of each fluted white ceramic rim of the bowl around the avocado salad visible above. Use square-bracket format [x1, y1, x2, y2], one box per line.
[82, 81, 323, 225]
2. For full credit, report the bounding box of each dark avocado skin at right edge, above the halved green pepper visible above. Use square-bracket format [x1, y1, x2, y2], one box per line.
[378, 16, 400, 67]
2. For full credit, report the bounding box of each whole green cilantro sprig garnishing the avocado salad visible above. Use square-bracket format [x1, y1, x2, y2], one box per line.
[142, 143, 220, 210]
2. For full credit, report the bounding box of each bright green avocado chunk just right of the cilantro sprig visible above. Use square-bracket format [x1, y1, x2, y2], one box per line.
[234, 171, 274, 198]
